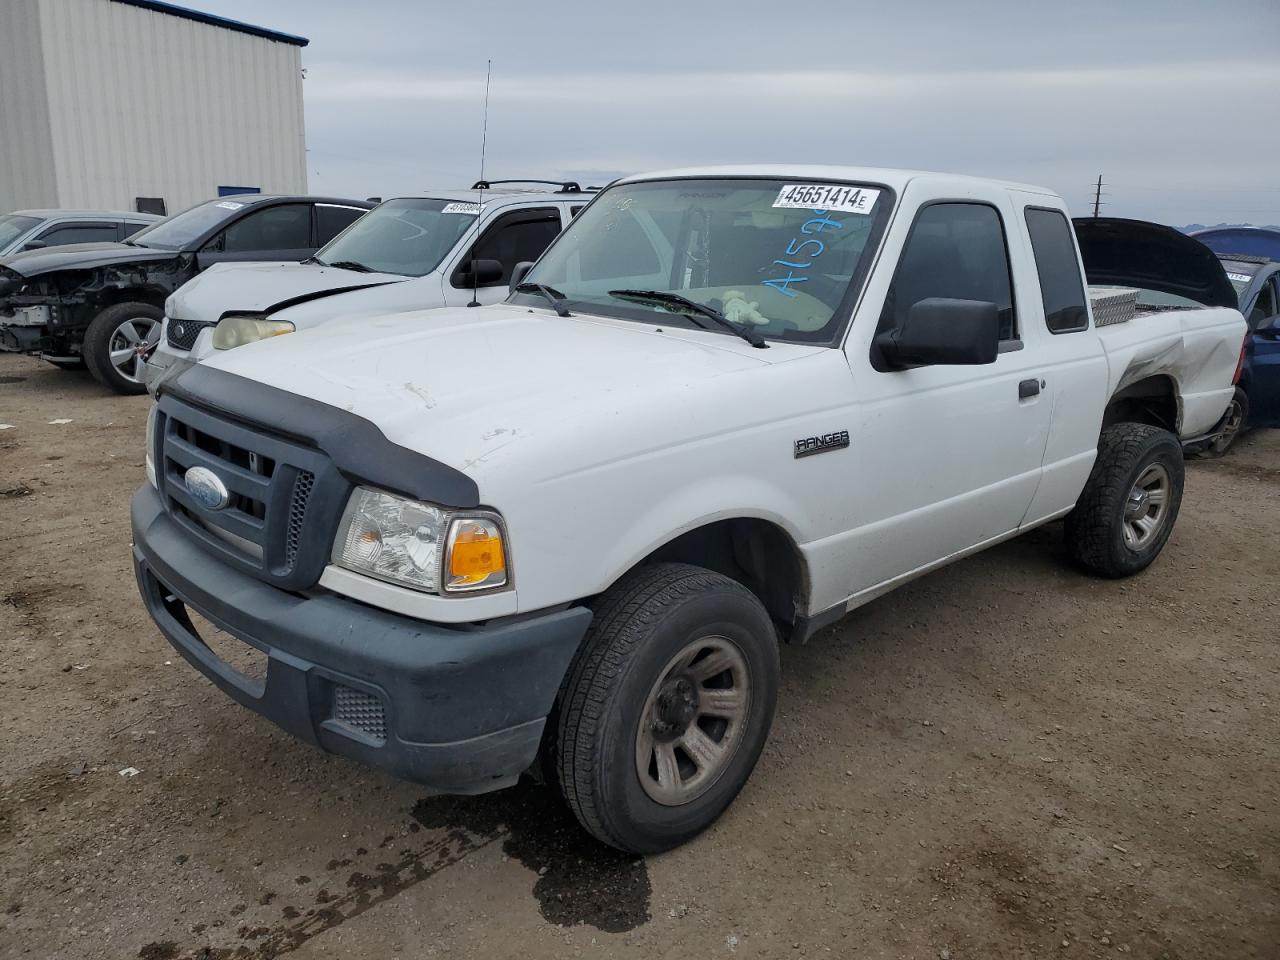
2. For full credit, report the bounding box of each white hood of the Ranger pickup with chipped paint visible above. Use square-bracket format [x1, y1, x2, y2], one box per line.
[194, 305, 824, 480]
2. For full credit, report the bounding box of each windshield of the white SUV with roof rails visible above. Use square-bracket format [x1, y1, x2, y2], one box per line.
[316, 197, 480, 276]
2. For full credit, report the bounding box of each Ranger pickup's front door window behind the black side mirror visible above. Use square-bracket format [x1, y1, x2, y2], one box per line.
[878, 201, 1018, 342]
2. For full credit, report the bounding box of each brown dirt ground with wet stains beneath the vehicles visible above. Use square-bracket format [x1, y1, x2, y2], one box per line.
[0, 357, 1280, 960]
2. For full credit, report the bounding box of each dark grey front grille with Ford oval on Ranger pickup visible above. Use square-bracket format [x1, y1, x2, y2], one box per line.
[154, 394, 351, 590]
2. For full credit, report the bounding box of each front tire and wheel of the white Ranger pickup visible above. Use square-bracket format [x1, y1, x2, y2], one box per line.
[553, 563, 778, 854]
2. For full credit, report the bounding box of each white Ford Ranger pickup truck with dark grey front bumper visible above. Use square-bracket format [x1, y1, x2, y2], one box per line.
[133, 165, 1245, 852]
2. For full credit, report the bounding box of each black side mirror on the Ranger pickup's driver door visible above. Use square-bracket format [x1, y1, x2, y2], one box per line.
[876, 297, 1000, 367]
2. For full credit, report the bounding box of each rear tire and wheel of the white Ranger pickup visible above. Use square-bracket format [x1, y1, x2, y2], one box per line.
[1066, 424, 1183, 577]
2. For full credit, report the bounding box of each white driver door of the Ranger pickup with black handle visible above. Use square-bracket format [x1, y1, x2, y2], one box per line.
[837, 187, 1053, 596]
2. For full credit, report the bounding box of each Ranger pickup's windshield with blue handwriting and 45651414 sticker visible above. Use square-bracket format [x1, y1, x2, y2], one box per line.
[515, 178, 892, 342]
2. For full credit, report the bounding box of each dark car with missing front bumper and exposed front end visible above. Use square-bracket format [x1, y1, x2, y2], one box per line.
[0, 195, 374, 393]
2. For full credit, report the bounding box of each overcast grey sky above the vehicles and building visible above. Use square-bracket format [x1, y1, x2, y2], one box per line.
[199, 0, 1280, 225]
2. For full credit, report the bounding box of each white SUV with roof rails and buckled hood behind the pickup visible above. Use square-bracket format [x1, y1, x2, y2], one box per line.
[147, 180, 594, 388]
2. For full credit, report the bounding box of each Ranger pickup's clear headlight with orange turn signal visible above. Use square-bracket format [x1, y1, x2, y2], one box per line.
[333, 486, 509, 594]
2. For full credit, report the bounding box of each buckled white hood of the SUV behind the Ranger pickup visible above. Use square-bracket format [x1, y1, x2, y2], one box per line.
[169, 264, 408, 321]
